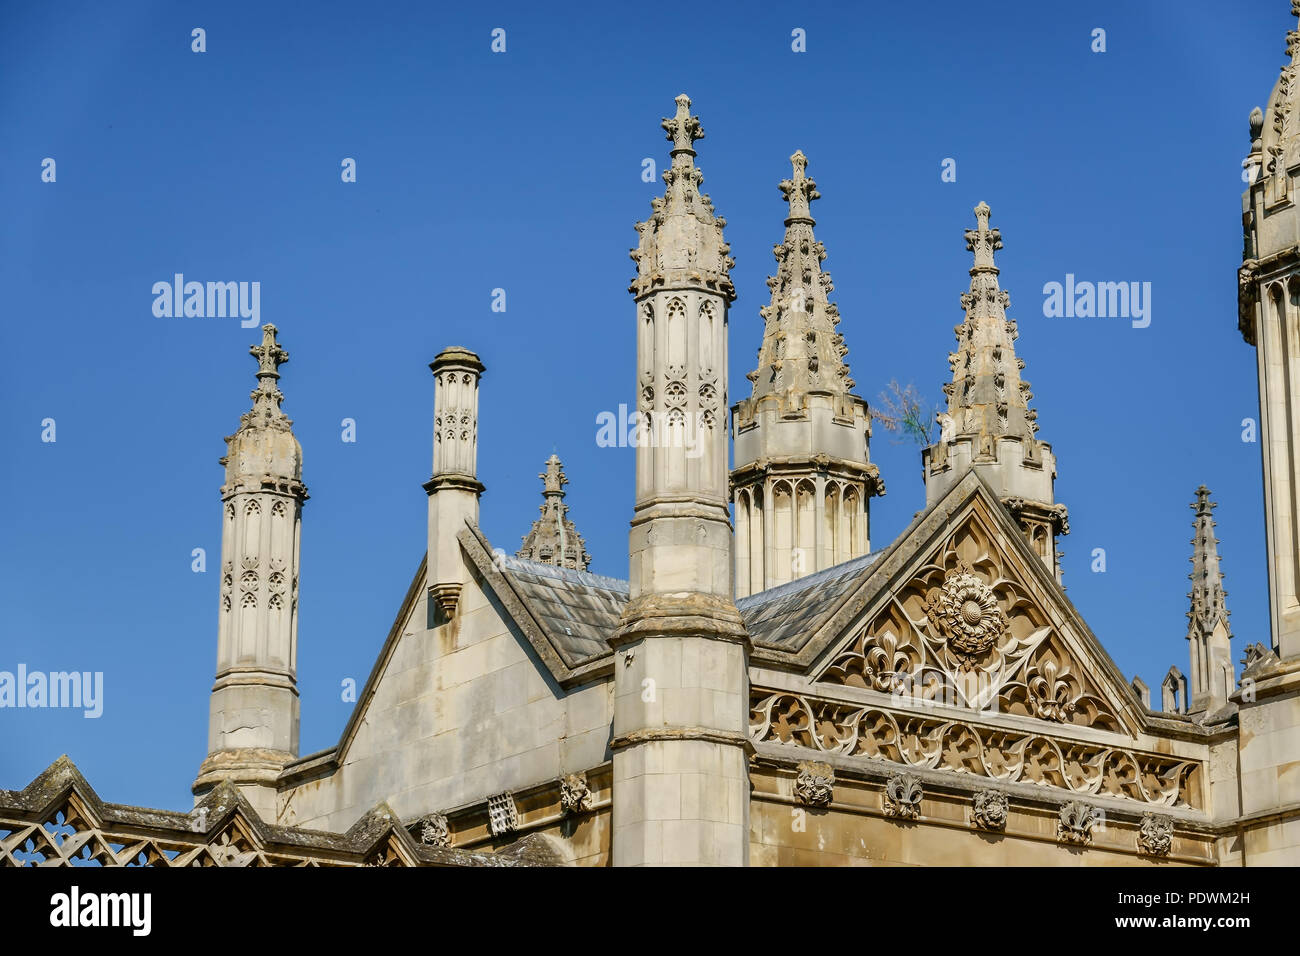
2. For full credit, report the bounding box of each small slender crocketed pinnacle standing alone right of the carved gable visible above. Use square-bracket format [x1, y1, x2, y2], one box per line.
[1187, 485, 1234, 711]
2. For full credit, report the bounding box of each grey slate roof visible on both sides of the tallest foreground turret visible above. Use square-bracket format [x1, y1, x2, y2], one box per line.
[497, 551, 884, 667]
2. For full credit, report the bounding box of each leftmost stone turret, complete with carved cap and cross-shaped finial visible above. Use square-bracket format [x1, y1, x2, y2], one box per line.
[194, 325, 307, 821]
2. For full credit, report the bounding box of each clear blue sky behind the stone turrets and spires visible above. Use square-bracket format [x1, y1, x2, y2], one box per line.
[0, 0, 1294, 808]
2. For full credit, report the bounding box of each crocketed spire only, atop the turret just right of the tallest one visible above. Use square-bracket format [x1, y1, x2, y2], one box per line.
[748, 152, 854, 411]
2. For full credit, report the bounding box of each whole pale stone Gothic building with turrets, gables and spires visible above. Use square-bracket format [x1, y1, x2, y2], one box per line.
[0, 11, 1300, 866]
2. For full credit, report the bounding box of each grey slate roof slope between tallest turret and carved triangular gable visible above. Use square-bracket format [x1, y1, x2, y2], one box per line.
[736, 550, 884, 650]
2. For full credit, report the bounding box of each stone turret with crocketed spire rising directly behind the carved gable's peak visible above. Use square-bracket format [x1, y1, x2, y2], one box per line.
[922, 203, 1070, 580]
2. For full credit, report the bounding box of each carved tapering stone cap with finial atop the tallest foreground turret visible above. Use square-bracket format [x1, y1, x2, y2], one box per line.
[628, 94, 736, 302]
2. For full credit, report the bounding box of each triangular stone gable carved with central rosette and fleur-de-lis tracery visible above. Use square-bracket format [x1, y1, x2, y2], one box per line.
[805, 471, 1144, 734]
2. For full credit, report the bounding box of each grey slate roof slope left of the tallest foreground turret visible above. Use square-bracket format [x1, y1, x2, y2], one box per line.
[497, 553, 628, 667]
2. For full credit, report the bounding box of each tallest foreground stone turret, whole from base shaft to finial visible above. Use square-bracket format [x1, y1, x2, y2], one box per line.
[610, 94, 750, 866]
